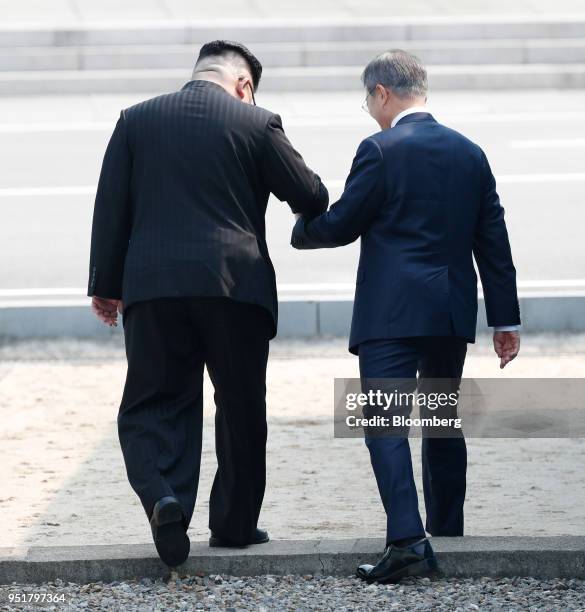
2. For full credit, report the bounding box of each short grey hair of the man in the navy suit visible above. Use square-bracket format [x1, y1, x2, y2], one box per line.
[362, 49, 428, 98]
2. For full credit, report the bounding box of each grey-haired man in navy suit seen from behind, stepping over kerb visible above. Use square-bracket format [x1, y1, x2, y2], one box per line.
[291, 50, 520, 582]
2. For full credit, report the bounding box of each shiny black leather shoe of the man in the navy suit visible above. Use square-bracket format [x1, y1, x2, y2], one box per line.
[356, 538, 438, 584]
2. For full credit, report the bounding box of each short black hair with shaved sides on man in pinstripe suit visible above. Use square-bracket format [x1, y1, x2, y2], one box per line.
[193, 40, 262, 91]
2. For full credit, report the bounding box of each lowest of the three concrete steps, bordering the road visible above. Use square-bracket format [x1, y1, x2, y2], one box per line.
[0, 63, 585, 95]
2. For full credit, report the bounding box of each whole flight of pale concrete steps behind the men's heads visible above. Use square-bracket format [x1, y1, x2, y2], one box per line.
[0, 17, 585, 95]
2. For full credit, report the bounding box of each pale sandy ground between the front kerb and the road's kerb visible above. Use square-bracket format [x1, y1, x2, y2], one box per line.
[0, 337, 585, 546]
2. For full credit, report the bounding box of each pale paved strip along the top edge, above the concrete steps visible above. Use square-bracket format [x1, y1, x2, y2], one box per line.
[0, 0, 585, 26]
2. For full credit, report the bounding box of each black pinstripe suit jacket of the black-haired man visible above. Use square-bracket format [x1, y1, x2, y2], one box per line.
[87, 81, 328, 333]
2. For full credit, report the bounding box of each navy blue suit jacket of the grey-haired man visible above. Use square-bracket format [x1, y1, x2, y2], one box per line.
[291, 112, 520, 354]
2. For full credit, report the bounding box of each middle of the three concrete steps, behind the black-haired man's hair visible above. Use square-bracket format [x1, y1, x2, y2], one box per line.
[0, 38, 585, 71]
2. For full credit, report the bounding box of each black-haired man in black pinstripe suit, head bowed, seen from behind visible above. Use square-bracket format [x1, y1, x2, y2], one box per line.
[87, 41, 328, 566]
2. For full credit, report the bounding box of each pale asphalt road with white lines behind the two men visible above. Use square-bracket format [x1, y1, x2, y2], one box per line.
[0, 91, 585, 291]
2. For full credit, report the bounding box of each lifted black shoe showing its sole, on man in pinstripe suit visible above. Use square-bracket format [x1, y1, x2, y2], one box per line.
[150, 495, 191, 567]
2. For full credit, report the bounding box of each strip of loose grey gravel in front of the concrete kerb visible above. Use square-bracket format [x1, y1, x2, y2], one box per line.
[0, 575, 585, 612]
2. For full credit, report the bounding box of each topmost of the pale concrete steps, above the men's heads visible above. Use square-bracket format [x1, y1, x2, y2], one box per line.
[0, 15, 585, 47]
